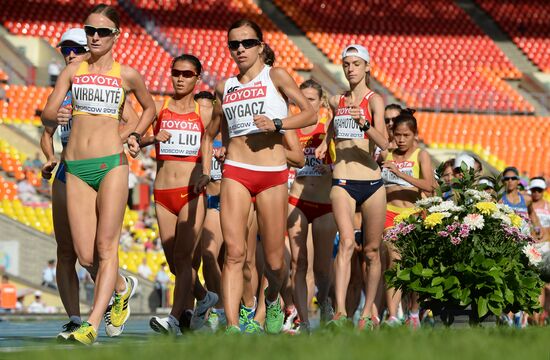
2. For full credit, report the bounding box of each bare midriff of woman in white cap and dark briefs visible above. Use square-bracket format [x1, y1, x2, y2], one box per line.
[332, 139, 381, 180]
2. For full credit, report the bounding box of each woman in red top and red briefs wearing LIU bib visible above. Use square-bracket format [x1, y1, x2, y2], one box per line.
[141, 54, 218, 333]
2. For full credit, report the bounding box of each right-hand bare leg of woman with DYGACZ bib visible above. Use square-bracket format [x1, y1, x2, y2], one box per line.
[256, 183, 288, 302]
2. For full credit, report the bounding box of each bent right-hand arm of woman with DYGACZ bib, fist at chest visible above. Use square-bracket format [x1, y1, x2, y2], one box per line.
[254, 68, 317, 131]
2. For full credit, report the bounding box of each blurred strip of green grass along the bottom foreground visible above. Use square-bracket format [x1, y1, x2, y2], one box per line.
[4, 328, 550, 360]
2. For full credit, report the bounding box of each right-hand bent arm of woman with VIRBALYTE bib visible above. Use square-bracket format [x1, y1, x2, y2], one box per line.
[121, 66, 155, 154]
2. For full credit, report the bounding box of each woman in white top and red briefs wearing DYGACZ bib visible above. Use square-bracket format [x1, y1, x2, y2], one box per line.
[204, 20, 315, 333]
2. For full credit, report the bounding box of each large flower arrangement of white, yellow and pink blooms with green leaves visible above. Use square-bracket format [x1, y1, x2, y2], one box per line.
[384, 169, 550, 323]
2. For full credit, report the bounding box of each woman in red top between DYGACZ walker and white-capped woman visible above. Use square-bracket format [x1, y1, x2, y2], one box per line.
[288, 80, 336, 332]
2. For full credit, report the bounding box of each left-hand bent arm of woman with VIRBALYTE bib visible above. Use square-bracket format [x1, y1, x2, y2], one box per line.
[40, 62, 80, 127]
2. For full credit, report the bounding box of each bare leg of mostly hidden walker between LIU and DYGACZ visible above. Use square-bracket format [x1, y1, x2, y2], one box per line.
[201, 209, 223, 309]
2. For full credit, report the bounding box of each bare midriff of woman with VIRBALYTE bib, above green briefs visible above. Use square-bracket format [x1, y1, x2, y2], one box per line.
[64, 115, 123, 160]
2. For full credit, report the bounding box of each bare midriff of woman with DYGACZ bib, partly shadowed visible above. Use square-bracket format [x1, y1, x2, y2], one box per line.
[226, 133, 286, 166]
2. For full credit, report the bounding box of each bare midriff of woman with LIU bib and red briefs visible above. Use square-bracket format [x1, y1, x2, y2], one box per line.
[153, 160, 202, 190]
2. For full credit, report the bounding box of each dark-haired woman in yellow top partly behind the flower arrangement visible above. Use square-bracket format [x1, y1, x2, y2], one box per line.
[381, 109, 434, 328]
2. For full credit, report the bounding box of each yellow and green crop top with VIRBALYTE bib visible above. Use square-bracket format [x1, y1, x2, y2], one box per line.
[71, 61, 125, 120]
